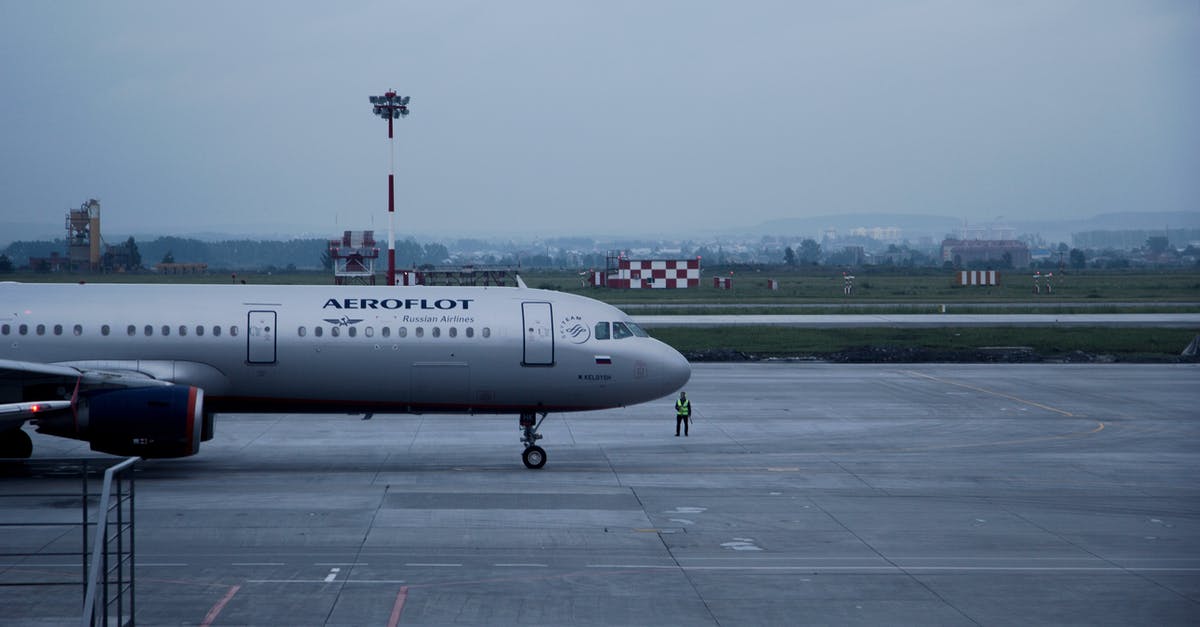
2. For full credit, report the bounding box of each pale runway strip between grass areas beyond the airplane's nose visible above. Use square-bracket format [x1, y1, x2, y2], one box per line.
[631, 314, 1200, 329]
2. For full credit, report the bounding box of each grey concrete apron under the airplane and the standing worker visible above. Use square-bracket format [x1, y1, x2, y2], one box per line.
[0, 364, 1200, 626]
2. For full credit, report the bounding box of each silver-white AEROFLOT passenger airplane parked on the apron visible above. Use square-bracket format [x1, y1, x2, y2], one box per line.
[0, 282, 691, 468]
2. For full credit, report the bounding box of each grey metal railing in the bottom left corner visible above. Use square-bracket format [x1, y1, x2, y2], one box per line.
[0, 458, 139, 625]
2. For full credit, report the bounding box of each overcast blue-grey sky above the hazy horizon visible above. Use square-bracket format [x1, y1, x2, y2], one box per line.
[0, 0, 1200, 237]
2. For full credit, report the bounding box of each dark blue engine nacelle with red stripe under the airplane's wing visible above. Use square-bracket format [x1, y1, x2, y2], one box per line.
[83, 386, 205, 458]
